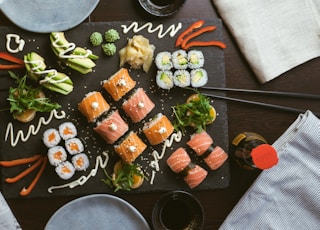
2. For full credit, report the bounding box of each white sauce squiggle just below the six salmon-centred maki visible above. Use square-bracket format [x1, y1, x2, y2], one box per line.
[48, 152, 109, 193]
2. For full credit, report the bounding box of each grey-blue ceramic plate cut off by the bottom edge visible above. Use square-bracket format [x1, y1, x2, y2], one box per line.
[45, 194, 150, 230]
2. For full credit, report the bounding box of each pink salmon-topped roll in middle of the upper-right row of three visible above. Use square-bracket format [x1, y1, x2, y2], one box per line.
[122, 88, 155, 123]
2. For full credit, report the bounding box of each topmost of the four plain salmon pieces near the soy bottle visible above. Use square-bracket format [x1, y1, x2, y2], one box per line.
[187, 131, 213, 156]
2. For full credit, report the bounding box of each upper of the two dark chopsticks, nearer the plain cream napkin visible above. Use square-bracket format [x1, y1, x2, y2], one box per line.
[201, 86, 320, 99]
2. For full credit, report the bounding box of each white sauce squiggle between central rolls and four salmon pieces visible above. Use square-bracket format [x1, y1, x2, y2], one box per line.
[149, 131, 182, 184]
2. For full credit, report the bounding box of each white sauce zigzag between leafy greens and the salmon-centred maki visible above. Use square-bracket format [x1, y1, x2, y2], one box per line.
[4, 109, 66, 147]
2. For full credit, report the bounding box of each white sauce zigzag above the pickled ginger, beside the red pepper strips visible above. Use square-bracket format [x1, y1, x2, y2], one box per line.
[121, 22, 182, 38]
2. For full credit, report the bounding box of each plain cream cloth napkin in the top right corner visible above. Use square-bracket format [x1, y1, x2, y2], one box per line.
[212, 0, 320, 83]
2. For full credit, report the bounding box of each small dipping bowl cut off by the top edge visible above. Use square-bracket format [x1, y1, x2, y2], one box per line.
[139, 0, 186, 17]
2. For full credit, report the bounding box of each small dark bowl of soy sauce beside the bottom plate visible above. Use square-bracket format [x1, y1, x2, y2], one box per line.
[152, 191, 205, 230]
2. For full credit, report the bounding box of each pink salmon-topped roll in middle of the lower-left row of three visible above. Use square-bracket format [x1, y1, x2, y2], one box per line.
[93, 110, 129, 144]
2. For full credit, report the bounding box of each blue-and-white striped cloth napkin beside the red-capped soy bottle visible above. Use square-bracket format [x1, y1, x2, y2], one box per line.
[220, 111, 320, 230]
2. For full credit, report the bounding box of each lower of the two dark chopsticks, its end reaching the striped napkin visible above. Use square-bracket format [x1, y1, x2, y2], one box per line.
[201, 92, 320, 117]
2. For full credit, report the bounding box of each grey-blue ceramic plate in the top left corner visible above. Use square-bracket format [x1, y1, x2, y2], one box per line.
[0, 0, 99, 33]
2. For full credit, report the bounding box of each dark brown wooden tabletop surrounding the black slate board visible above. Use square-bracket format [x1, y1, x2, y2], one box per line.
[0, 0, 320, 230]
